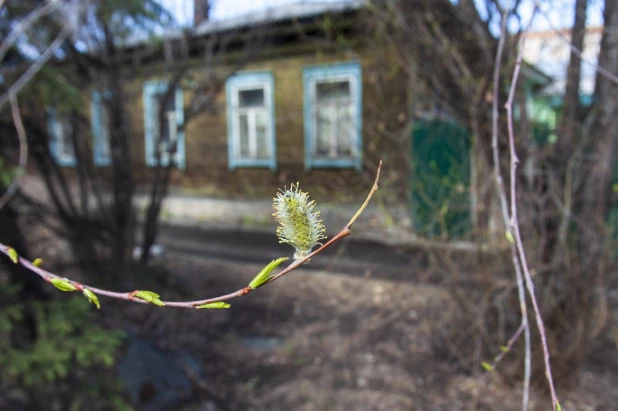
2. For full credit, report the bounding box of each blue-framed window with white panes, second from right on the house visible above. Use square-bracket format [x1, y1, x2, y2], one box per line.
[225, 73, 277, 170]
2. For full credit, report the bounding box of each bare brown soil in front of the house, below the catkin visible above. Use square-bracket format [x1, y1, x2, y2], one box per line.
[91, 253, 618, 411]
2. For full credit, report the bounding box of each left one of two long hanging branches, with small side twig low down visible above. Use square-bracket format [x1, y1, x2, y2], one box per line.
[491, 4, 532, 411]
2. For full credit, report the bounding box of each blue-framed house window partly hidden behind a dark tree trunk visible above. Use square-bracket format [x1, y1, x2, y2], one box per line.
[144, 81, 185, 169]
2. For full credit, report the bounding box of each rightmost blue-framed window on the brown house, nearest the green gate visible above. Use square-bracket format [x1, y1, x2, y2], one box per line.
[303, 62, 363, 171]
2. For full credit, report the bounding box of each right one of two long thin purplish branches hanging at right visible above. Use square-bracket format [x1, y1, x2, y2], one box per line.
[504, 7, 559, 411]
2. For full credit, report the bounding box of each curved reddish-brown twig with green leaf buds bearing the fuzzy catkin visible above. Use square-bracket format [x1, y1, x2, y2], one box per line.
[0, 161, 382, 308]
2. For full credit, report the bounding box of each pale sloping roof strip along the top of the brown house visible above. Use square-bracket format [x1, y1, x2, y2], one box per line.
[193, 0, 367, 36]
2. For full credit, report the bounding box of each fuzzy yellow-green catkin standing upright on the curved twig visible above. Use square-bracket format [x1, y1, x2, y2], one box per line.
[273, 183, 326, 260]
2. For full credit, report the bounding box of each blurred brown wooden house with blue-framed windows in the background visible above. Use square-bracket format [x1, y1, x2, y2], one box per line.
[37, 1, 410, 243]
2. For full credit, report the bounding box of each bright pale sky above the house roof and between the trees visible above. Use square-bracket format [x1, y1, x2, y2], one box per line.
[160, 0, 603, 30]
